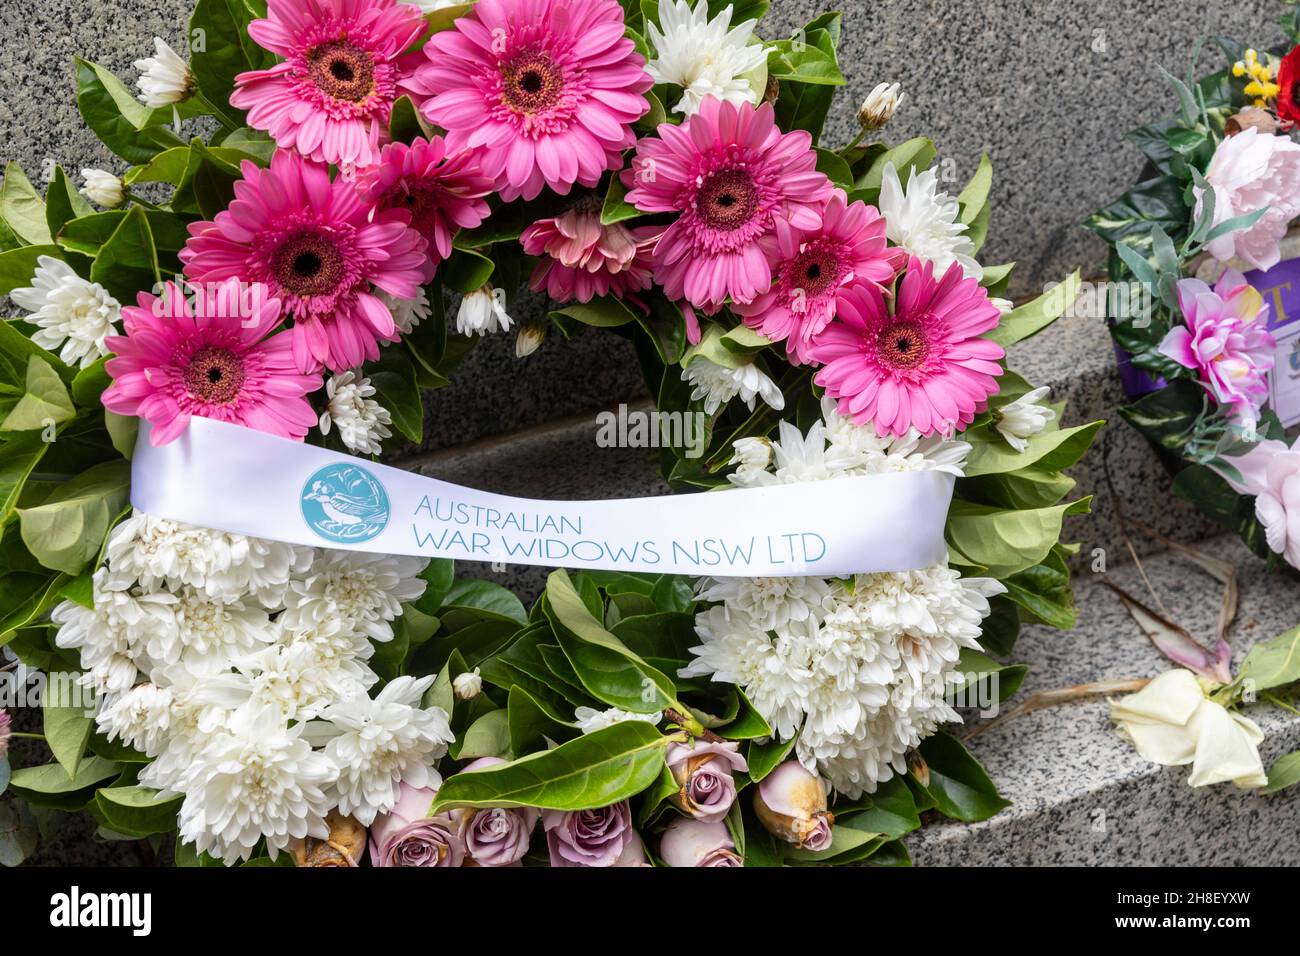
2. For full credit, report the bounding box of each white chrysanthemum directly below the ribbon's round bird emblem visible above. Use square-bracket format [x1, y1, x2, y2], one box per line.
[278, 550, 429, 641]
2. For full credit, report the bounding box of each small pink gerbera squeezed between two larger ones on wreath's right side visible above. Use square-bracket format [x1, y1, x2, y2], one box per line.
[736, 190, 906, 362]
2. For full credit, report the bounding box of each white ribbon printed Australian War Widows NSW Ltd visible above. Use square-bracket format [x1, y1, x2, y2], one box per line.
[131, 418, 954, 578]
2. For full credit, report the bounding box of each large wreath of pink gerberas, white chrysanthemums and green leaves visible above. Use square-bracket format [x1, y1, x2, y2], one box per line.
[0, 0, 1100, 866]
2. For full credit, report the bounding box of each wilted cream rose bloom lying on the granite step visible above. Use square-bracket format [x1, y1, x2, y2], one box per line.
[1110, 670, 1269, 787]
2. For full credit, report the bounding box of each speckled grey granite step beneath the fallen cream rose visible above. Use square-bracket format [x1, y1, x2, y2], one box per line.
[907, 537, 1300, 866]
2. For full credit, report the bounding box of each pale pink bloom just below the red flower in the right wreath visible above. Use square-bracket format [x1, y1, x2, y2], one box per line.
[1193, 127, 1300, 269]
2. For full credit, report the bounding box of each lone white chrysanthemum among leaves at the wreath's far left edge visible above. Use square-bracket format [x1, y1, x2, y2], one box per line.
[9, 256, 122, 368]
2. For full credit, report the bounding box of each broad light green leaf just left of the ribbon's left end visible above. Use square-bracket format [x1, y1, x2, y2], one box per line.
[18, 460, 131, 575]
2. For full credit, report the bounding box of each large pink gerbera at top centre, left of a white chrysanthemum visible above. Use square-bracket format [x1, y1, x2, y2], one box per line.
[412, 0, 654, 202]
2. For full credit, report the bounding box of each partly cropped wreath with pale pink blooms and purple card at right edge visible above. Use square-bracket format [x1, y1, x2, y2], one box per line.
[1087, 7, 1300, 567]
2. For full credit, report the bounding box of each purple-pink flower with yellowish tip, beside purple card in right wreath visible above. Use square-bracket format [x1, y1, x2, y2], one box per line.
[1160, 269, 1277, 428]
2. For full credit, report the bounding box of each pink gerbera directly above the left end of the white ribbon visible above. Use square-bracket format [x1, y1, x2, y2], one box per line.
[103, 280, 321, 445]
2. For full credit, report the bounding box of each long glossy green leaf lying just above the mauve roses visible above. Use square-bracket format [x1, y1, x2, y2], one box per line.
[429, 721, 673, 816]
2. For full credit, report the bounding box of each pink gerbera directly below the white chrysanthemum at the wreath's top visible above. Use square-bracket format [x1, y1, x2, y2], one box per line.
[623, 96, 832, 315]
